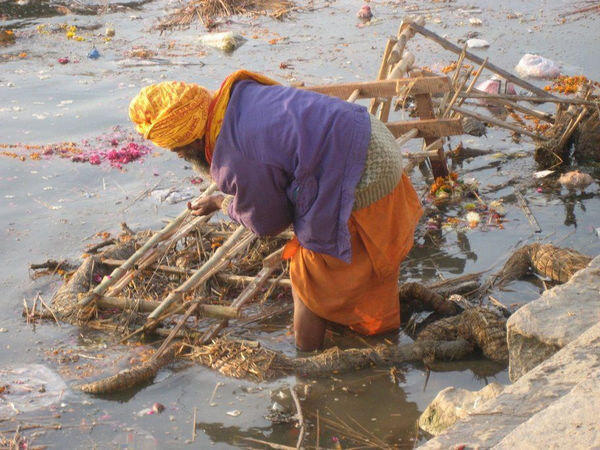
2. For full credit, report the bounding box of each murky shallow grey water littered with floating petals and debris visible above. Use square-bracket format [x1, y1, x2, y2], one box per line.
[0, 0, 600, 448]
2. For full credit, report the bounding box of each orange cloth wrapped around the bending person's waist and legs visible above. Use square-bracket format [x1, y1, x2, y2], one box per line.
[285, 174, 423, 335]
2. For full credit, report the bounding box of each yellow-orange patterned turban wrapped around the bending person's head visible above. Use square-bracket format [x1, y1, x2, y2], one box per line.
[129, 81, 211, 149]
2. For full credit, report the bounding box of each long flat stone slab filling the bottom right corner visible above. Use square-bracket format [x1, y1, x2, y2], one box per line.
[420, 324, 600, 450]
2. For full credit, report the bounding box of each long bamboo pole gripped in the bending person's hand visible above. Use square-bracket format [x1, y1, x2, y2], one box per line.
[78, 183, 217, 308]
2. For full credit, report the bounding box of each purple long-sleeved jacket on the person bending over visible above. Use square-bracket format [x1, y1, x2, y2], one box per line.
[210, 80, 371, 263]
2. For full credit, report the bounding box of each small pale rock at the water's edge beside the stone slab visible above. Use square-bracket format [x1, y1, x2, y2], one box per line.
[419, 383, 504, 436]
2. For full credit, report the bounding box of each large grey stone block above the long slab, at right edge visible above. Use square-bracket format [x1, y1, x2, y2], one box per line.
[506, 257, 600, 382]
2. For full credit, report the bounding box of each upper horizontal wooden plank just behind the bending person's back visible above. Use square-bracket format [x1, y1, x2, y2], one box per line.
[300, 76, 450, 100]
